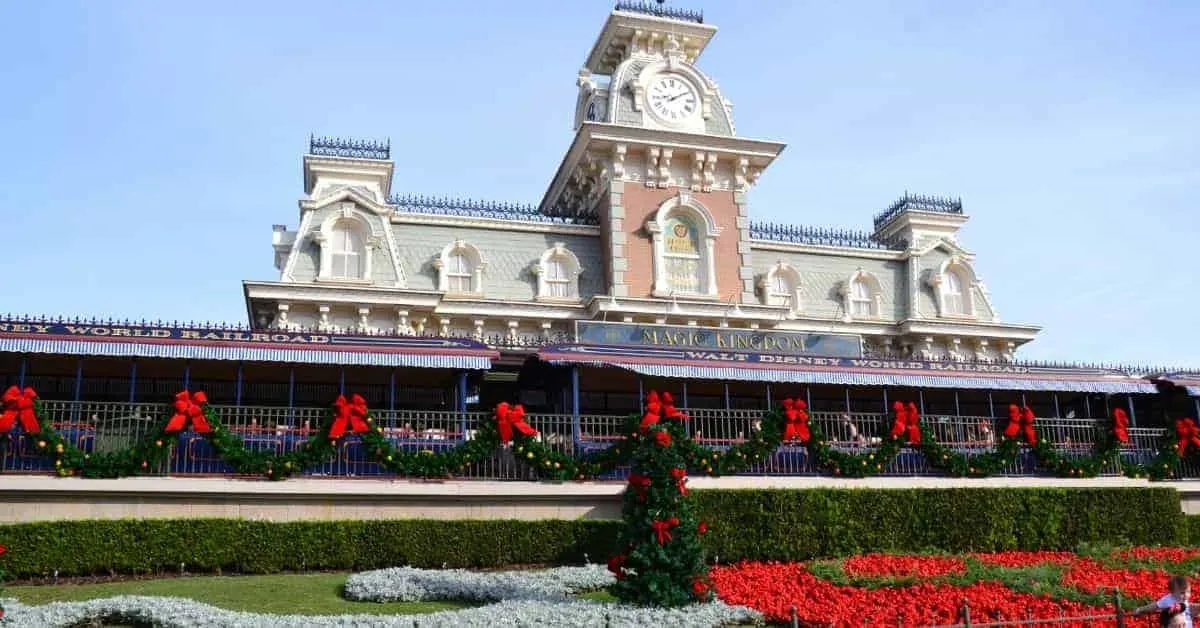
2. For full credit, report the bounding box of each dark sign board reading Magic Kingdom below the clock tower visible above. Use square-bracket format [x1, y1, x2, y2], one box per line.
[575, 321, 863, 358]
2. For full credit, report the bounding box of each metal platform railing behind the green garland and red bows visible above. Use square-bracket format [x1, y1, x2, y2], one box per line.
[0, 401, 1180, 480]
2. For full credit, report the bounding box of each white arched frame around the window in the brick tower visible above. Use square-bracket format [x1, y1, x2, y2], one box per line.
[646, 190, 720, 299]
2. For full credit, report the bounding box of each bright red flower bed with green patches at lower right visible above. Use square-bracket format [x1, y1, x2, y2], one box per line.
[712, 548, 1200, 627]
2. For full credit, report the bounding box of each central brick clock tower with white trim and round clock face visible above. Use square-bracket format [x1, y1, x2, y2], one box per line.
[541, 1, 784, 312]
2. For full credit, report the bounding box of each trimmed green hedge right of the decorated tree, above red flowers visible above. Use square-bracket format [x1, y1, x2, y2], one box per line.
[696, 488, 1185, 562]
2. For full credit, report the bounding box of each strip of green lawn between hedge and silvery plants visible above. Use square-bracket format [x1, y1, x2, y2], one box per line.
[4, 573, 470, 615]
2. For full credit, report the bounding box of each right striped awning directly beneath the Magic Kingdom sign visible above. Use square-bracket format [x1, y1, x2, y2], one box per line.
[539, 345, 1157, 394]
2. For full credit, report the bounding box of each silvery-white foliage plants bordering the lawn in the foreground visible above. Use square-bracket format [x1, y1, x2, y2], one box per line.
[0, 566, 762, 628]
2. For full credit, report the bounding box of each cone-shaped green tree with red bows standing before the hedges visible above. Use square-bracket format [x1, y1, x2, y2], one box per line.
[608, 391, 712, 606]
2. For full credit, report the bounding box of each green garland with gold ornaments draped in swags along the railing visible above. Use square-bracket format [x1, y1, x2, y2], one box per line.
[0, 389, 1200, 482]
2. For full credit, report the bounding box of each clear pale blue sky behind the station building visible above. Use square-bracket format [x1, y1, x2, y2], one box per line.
[0, 0, 1200, 365]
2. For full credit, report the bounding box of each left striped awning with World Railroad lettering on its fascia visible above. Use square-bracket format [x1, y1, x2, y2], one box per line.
[0, 322, 499, 370]
